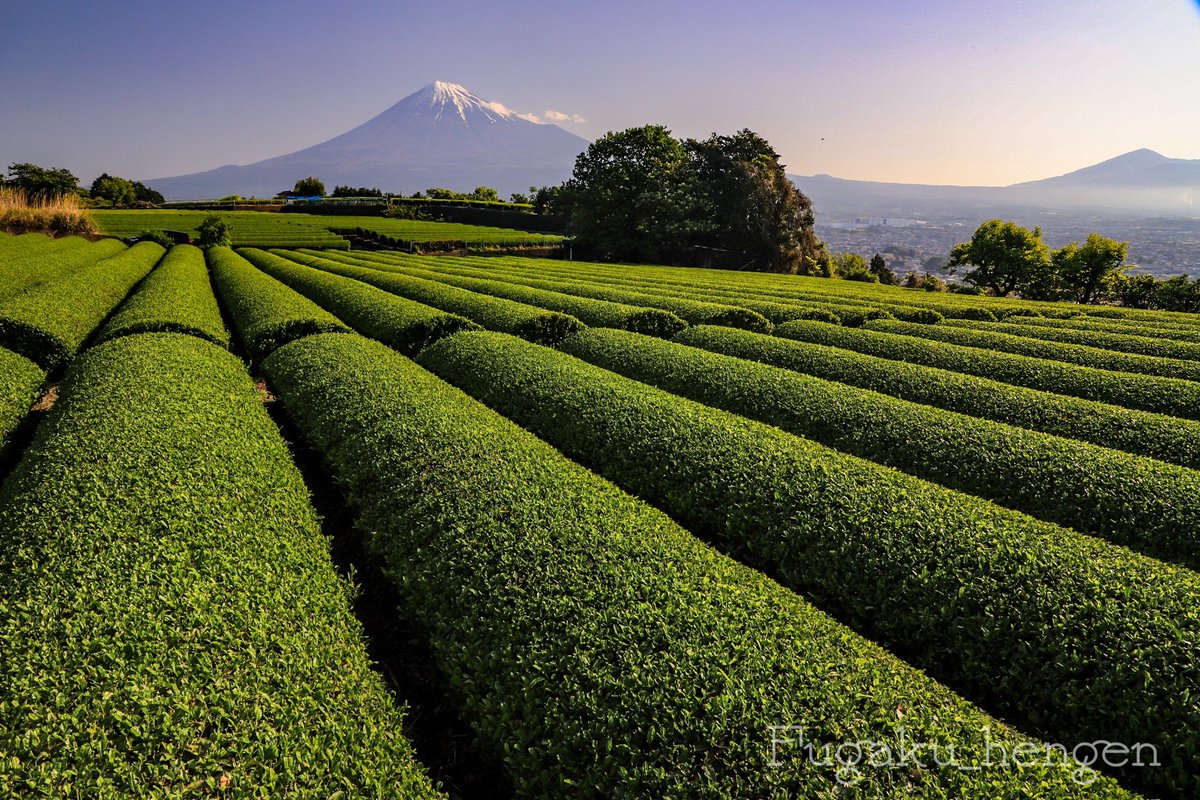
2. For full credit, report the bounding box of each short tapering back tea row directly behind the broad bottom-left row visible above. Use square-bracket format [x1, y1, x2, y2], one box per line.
[98, 245, 229, 347]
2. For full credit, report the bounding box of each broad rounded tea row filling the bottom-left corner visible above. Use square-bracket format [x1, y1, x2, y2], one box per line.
[0, 333, 437, 798]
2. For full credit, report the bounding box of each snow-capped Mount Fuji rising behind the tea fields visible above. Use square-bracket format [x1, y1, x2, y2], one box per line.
[145, 80, 588, 200]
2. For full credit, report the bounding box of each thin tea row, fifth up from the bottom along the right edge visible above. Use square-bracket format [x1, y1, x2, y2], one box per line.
[869, 320, 1200, 381]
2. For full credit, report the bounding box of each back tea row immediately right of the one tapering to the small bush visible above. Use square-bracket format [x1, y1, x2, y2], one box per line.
[241, 248, 479, 355]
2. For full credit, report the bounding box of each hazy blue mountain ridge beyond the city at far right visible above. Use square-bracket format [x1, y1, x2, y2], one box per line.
[790, 149, 1200, 217]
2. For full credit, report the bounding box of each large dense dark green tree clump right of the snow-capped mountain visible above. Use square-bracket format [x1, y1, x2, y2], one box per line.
[559, 125, 824, 272]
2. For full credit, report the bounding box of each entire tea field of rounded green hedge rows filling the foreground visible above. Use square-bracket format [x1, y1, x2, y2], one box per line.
[0, 227, 1200, 800]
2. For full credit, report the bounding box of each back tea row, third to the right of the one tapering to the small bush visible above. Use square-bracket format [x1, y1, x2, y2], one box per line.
[328, 256, 688, 338]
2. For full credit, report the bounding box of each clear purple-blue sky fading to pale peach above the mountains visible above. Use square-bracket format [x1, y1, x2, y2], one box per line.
[0, 0, 1200, 185]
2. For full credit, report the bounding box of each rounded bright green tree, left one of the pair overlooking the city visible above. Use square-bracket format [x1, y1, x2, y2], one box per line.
[949, 219, 1054, 299]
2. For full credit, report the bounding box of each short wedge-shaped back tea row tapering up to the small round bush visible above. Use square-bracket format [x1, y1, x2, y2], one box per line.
[204, 247, 350, 360]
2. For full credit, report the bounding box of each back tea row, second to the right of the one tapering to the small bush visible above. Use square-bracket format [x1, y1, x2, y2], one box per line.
[281, 251, 583, 344]
